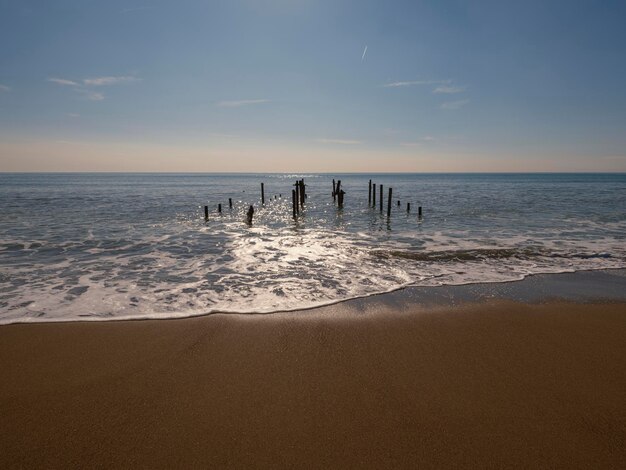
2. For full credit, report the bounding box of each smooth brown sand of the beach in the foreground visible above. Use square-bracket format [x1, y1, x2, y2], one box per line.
[0, 301, 626, 469]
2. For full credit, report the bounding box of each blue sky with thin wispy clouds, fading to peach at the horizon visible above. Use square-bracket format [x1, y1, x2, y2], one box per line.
[0, 0, 626, 173]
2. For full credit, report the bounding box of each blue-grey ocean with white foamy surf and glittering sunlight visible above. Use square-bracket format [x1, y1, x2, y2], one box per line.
[0, 174, 626, 324]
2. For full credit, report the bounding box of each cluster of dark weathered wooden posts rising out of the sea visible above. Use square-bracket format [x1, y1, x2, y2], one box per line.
[204, 179, 422, 225]
